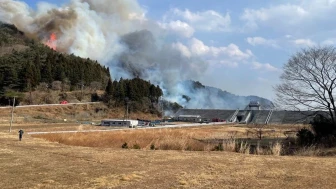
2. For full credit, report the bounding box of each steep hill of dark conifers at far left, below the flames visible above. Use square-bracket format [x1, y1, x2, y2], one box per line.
[0, 23, 110, 95]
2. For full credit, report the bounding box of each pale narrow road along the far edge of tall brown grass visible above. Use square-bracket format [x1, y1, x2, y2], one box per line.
[27, 122, 231, 135]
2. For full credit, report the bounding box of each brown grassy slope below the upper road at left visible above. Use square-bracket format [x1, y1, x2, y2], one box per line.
[0, 103, 158, 125]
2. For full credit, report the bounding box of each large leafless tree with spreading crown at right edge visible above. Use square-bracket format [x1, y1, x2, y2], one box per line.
[275, 46, 336, 124]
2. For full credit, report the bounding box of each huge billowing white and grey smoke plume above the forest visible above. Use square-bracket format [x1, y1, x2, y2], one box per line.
[0, 0, 270, 108]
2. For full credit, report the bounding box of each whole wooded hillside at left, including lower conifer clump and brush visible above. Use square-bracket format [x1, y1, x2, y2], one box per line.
[0, 23, 167, 114]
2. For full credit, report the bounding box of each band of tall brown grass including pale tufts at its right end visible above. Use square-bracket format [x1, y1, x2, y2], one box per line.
[34, 126, 288, 155]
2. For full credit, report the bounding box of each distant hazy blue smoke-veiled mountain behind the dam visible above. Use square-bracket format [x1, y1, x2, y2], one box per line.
[180, 80, 274, 109]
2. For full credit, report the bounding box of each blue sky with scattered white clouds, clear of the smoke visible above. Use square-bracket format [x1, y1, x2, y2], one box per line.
[18, 0, 336, 100]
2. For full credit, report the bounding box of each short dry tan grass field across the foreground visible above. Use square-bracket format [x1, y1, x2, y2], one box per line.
[0, 127, 336, 188]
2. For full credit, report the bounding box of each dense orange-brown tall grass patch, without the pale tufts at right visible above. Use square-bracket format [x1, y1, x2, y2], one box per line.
[35, 129, 205, 150]
